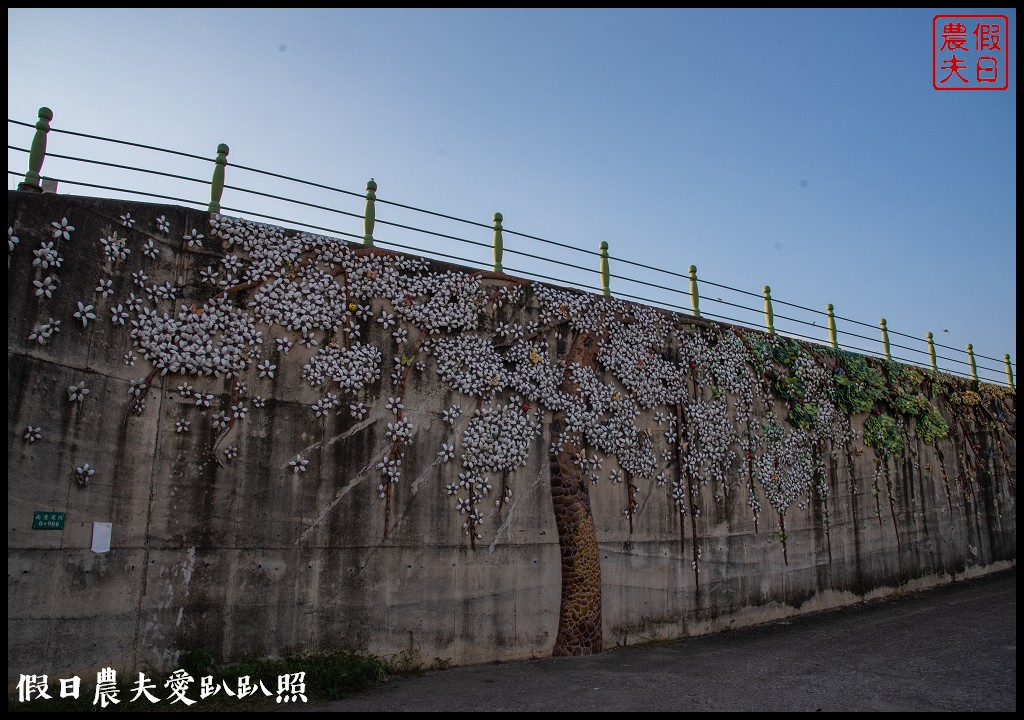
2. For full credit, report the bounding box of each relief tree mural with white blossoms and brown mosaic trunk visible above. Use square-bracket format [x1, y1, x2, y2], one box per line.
[8, 199, 1009, 654]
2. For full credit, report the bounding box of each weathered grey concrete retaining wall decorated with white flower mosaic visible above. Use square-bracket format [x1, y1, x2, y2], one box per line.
[7, 193, 1017, 678]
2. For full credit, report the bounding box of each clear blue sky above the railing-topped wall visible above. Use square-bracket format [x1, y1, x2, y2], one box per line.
[7, 8, 1018, 382]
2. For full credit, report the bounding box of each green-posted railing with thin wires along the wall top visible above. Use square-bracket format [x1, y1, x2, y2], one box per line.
[7, 108, 1015, 387]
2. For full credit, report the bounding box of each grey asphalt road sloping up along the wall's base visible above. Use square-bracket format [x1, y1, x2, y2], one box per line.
[303, 568, 1017, 712]
